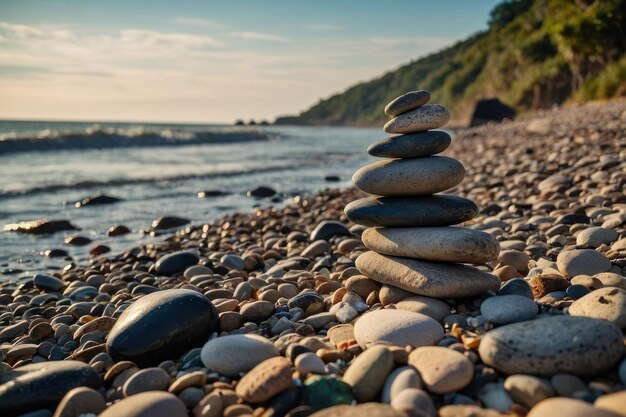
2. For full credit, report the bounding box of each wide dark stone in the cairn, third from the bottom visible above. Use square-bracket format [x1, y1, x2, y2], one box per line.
[344, 195, 478, 227]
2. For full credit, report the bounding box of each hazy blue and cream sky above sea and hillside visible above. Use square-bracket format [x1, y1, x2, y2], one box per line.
[0, 0, 499, 123]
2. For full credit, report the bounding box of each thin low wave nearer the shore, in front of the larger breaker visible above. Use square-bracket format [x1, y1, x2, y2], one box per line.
[0, 163, 304, 200]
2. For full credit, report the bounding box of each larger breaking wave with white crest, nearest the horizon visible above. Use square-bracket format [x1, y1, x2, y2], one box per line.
[0, 125, 279, 155]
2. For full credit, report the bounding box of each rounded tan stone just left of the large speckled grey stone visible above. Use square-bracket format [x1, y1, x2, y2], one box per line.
[409, 346, 474, 394]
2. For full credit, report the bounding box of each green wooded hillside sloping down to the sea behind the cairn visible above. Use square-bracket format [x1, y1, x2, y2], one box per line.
[277, 0, 626, 125]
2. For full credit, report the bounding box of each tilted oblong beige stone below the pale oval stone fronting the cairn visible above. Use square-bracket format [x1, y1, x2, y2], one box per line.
[343, 346, 393, 402]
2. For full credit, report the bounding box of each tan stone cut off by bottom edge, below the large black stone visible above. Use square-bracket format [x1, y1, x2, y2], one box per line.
[98, 391, 188, 417]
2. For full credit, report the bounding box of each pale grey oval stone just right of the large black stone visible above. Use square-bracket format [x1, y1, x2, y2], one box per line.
[200, 334, 280, 377]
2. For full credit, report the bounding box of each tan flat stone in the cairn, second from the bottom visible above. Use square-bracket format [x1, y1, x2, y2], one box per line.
[361, 227, 500, 264]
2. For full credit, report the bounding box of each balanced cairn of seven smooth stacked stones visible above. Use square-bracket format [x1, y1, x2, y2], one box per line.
[345, 90, 500, 299]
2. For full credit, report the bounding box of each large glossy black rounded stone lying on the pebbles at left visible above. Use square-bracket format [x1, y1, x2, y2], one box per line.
[106, 289, 218, 366]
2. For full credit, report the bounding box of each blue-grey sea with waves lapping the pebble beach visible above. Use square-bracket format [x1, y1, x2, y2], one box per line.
[0, 121, 385, 280]
